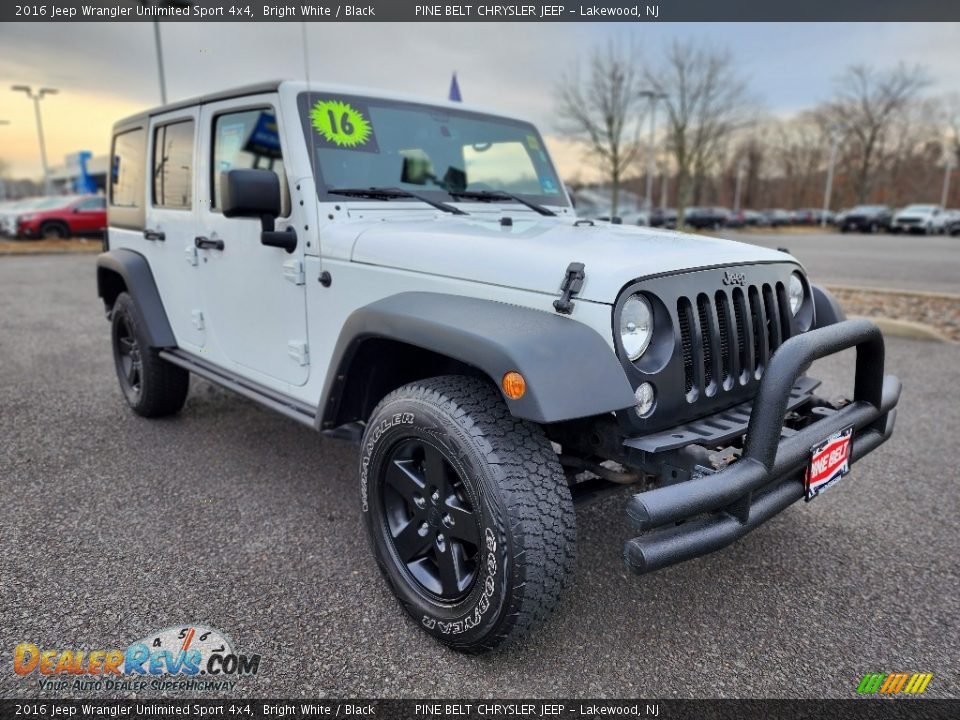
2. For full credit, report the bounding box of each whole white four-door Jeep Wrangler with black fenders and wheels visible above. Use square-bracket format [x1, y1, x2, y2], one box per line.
[97, 82, 900, 651]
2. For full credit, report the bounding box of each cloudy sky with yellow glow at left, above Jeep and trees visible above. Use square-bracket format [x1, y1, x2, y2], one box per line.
[0, 22, 960, 177]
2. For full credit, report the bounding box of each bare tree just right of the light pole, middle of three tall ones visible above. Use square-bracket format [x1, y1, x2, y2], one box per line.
[644, 41, 746, 228]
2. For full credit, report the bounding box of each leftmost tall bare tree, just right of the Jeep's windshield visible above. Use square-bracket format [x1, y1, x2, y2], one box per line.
[557, 42, 644, 215]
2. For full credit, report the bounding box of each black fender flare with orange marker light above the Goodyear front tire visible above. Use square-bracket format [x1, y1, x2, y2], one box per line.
[317, 292, 636, 423]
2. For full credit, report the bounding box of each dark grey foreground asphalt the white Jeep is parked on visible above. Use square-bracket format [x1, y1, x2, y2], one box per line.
[0, 252, 960, 698]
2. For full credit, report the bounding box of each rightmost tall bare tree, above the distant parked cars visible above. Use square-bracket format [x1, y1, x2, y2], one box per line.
[830, 63, 929, 203]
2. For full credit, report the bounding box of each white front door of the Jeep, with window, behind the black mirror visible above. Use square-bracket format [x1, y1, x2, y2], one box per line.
[197, 95, 310, 385]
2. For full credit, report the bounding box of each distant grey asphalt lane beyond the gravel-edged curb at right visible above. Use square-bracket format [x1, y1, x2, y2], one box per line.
[722, 228, 960, 293]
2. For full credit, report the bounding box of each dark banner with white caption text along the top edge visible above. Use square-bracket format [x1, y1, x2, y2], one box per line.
[0, 0, 960, 23]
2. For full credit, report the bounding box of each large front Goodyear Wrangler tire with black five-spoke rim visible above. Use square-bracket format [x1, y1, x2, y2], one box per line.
[360, 376, 575, 652]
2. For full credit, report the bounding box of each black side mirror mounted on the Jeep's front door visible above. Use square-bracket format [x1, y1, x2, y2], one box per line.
[220, 169, 297, 253]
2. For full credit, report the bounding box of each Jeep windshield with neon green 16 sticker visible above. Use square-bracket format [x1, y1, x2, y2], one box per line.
[299, 93, 568, 206]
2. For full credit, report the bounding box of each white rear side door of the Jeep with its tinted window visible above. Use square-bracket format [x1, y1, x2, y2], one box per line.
[140, 107, 206, 352]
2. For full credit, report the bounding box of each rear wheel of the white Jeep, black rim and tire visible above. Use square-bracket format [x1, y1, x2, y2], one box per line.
[110, 292, 190, 418]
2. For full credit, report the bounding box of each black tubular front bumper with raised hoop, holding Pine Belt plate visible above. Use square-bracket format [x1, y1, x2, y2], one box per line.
[623, 320, 900, 573]
